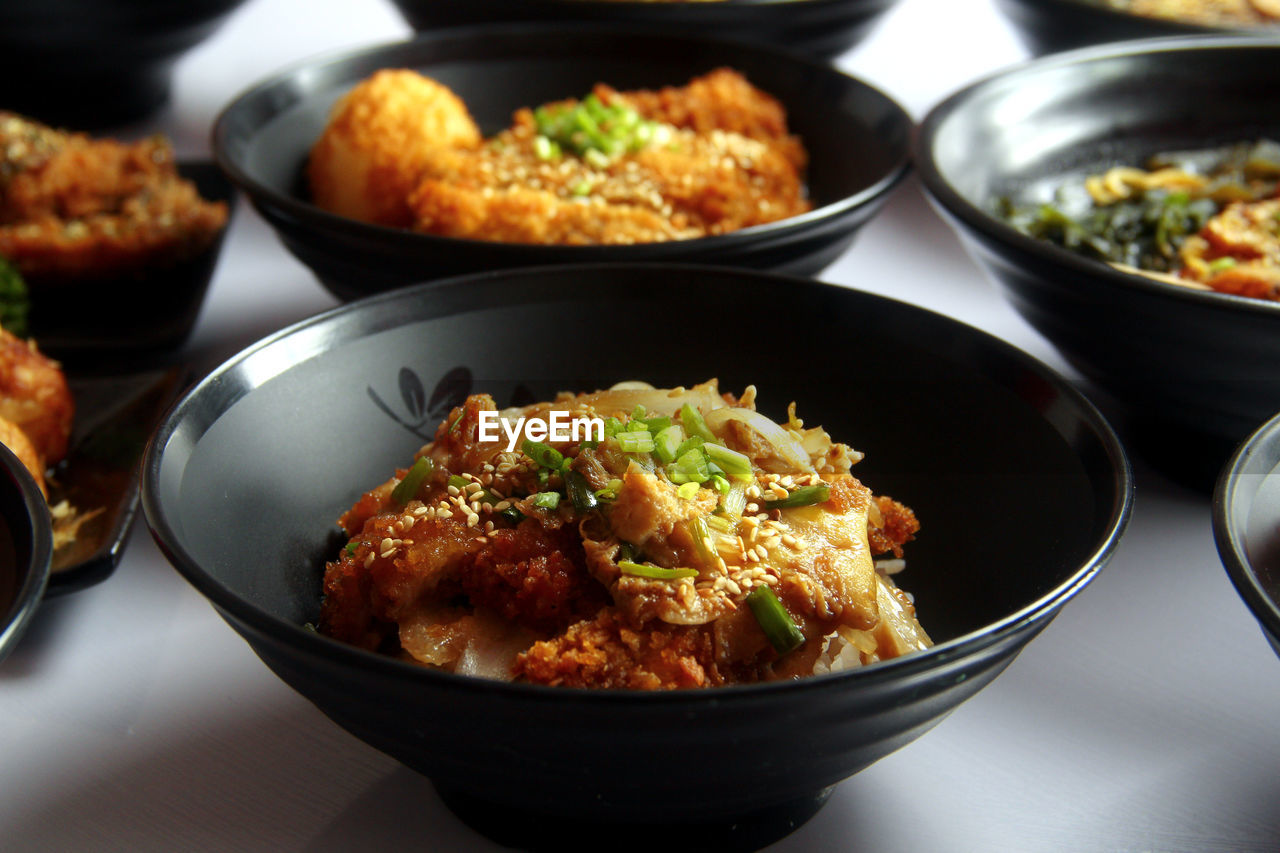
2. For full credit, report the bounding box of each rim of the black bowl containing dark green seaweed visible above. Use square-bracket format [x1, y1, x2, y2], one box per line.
[911, 35, 1280, 318]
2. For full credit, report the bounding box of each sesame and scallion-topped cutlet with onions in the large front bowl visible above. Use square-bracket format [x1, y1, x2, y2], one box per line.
[317, 382, 931, 689]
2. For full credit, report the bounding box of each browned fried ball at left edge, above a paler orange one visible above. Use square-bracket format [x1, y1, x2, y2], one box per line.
[0, 329, 76, 470]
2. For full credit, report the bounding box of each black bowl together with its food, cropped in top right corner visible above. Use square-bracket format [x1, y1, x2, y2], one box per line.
[996, 0, 1280, 56]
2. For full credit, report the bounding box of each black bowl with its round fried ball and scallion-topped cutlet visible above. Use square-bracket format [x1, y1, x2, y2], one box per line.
[214, 24, 911, 300]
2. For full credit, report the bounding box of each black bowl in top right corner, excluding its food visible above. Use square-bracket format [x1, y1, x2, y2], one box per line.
[996, 0, 1280, 55]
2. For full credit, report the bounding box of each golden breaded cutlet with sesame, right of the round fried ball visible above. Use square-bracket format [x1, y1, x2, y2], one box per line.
[410, 69, 809, 245]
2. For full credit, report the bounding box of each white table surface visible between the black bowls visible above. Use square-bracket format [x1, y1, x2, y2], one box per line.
[0, 0, 1280, 852]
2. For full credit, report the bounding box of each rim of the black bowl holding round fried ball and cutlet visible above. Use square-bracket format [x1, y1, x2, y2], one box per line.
[210, 24, 915, 264]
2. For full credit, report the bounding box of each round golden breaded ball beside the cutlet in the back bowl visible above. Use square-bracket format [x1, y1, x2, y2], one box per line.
[307, 69, 481, 227]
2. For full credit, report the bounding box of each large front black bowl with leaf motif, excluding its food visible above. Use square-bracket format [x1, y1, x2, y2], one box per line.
[142, 265, 1130, 849]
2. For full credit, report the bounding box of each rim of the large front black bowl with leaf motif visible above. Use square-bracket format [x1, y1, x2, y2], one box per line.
[142, 264, 1134, 704]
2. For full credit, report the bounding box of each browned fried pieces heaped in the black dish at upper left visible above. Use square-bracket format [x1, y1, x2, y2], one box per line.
[0, 113, 227, 286]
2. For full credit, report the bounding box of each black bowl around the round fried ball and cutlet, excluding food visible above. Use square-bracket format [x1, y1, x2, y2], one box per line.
[214, 26, 911, 300]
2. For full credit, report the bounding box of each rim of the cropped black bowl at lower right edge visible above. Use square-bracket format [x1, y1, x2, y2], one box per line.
[1212, 414, 1280, 643]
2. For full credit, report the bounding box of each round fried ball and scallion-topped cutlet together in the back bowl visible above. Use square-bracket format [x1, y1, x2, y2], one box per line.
[308, 69, 810, 245]
